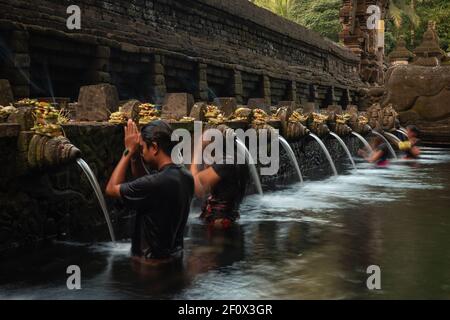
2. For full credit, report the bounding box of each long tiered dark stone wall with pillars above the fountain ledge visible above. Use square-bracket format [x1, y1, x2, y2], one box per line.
[0, 0, 362, 106]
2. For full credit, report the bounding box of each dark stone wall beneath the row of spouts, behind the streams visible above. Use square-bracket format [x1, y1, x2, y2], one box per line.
[0, 123, 359, 255]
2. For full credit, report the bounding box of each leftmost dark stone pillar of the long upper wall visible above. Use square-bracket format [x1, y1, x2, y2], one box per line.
[5, 30, 31, 99]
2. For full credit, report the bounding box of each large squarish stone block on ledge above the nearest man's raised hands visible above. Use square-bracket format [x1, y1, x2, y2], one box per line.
[76, 84, 119, 121]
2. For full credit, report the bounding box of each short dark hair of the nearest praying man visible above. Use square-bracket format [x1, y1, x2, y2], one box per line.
[141, 120, 175, 157]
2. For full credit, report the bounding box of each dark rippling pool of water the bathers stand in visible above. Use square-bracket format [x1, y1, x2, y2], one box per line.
[0, 148, 450, 299]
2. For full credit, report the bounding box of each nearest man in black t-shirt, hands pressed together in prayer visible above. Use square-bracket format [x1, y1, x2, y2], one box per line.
[106, 120, 194, 263]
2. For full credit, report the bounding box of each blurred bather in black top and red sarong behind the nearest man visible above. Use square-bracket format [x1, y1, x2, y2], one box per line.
[191, 131, 248, 229]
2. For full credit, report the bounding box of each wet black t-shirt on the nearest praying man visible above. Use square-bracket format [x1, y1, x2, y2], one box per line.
[120, 164, 194, 259]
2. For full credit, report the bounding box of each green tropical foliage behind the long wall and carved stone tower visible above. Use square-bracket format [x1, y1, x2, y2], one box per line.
[250, 0, 450, 53]
